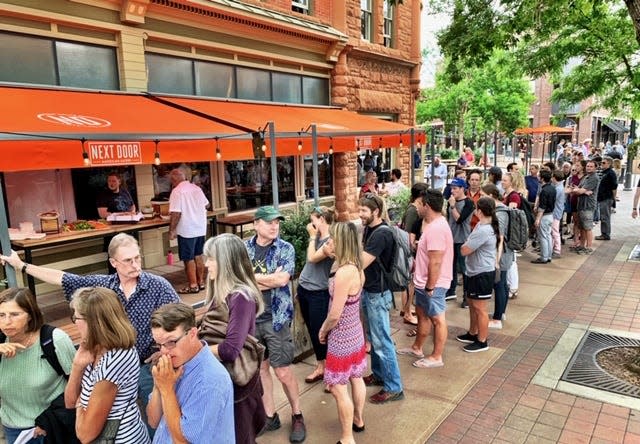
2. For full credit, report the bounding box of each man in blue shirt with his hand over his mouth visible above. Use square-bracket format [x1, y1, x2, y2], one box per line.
[147, 304, 235, 444]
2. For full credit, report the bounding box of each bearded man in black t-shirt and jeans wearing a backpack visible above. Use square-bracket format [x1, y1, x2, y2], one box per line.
[358, 193, 404, 404]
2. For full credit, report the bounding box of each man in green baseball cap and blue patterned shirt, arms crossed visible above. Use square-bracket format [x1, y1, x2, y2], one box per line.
[245, 206, 306, 442]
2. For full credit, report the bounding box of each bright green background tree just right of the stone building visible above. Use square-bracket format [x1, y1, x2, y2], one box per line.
[416, 51, 534, 147]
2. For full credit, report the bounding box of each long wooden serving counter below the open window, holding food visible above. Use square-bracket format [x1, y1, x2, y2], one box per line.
[11, 211, 219, 294]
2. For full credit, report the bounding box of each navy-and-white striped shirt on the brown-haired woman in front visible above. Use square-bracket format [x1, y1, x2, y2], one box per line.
[80, 347, 150, 444]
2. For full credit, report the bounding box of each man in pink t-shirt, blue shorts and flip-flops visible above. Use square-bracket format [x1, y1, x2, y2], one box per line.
[397, 189, 453, 368]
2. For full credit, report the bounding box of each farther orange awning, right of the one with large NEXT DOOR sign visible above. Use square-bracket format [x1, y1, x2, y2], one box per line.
[156, 96, 425, 156]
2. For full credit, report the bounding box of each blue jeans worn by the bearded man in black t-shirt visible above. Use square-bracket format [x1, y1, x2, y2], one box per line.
[362, 290, 402, 392]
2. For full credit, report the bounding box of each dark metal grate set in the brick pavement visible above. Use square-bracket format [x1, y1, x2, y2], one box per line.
[560, 331, 640, 398]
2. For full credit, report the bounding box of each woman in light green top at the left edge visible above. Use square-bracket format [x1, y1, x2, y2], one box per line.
[0, 288, 75, 444]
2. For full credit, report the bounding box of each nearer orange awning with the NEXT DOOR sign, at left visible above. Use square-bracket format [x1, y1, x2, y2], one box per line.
[0, 86, 253, 171]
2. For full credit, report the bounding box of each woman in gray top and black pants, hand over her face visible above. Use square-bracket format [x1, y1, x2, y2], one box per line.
[297, 207, 335, 384]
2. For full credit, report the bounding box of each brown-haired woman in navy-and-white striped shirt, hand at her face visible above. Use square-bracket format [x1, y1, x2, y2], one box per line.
[64, 287, 150, 444]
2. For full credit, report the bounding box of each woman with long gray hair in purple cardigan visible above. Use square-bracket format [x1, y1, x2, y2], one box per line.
[203, 233, 266, 444]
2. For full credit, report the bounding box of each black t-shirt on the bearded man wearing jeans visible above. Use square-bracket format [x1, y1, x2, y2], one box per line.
[362, 222, 393, 293]
